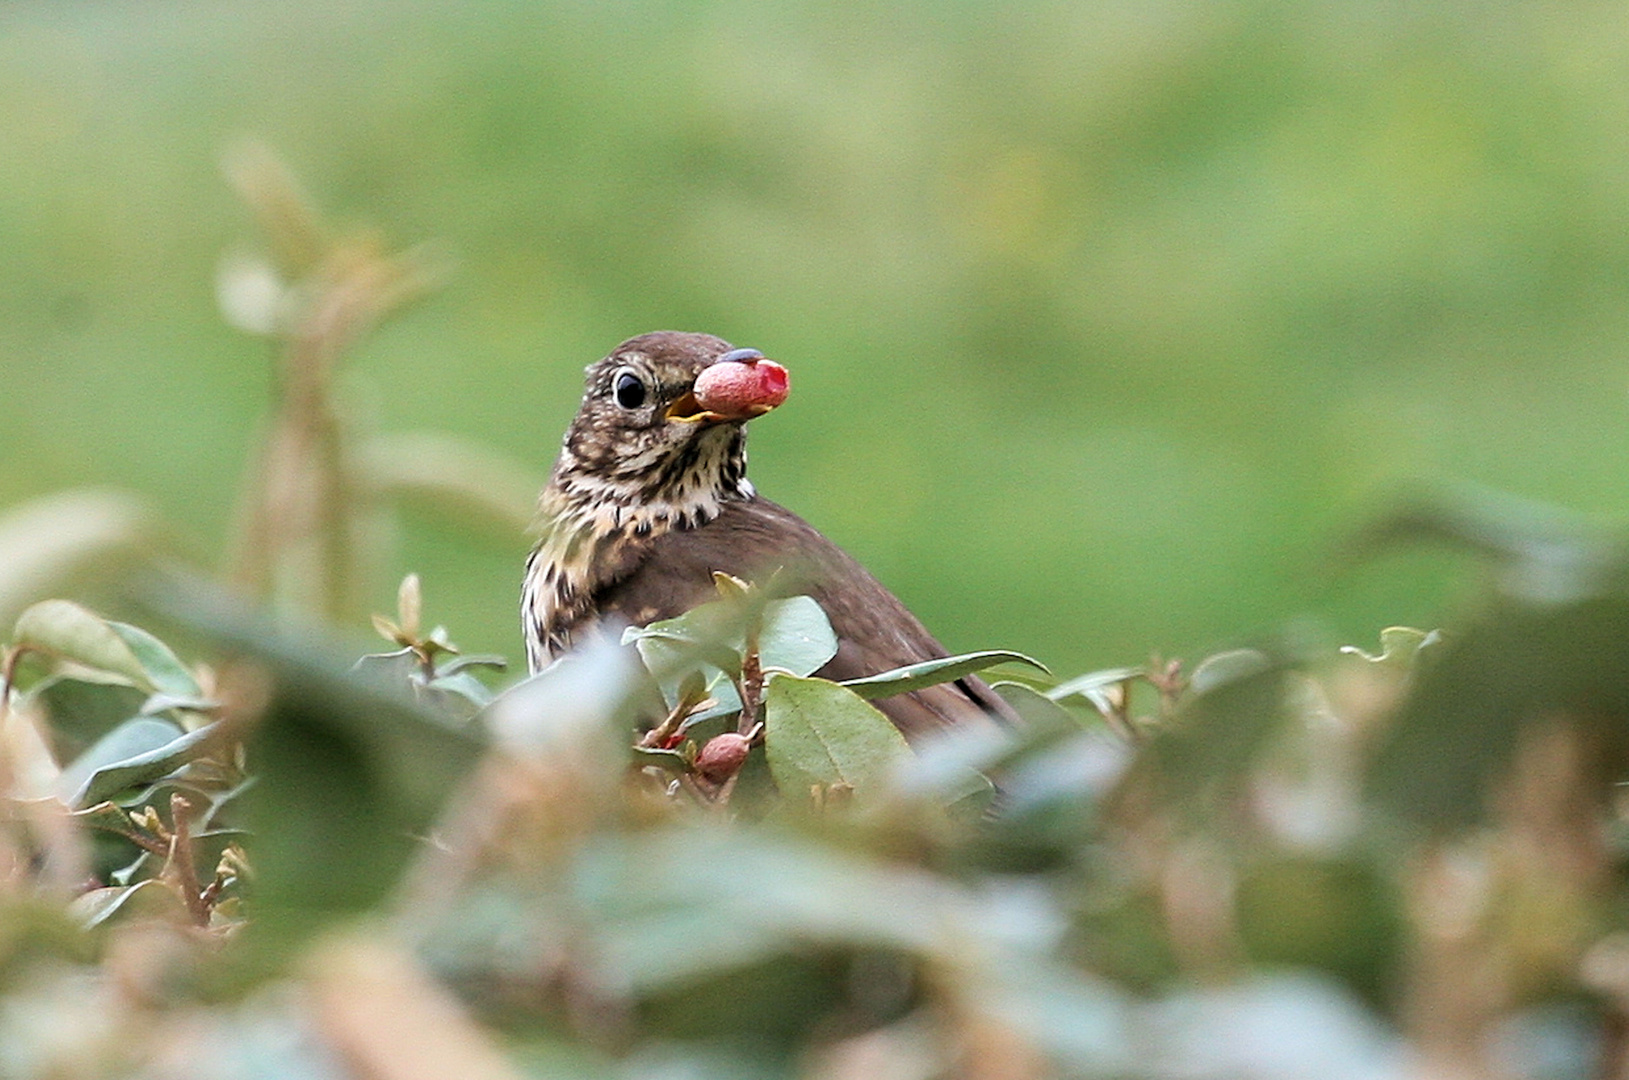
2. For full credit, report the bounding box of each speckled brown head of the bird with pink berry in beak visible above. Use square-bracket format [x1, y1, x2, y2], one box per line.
[552, 331, 787, 510]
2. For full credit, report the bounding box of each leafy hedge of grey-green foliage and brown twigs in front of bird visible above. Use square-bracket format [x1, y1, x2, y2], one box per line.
[9, 478, 1629, 1078]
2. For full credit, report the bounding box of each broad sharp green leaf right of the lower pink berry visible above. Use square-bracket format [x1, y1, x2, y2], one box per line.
[764, 673, 911, 798]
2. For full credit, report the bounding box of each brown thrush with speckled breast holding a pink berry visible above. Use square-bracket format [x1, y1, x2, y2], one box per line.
[521, 331, 1015, 741]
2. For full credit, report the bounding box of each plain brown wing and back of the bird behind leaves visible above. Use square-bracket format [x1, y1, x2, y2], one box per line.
[596, 498, 1015, 736]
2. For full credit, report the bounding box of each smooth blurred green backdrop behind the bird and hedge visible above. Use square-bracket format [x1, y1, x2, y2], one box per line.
[0, 0, 1629, 673]
